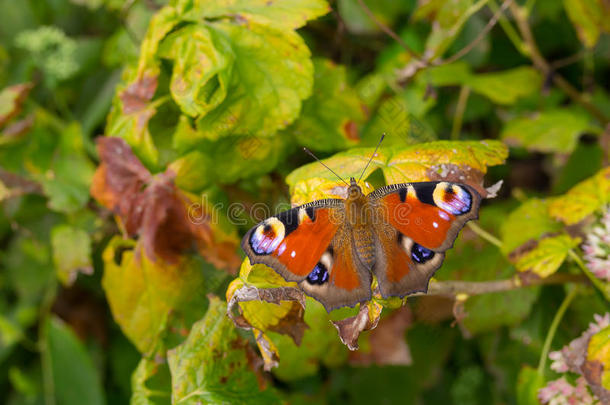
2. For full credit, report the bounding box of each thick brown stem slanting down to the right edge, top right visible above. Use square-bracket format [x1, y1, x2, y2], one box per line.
[509, 3, 610, 126]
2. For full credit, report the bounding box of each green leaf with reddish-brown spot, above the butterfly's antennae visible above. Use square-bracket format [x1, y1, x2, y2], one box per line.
[286, 59, 365, 151]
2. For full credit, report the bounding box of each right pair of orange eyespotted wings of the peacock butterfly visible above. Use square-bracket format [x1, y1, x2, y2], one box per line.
[368, 182, 481, 297]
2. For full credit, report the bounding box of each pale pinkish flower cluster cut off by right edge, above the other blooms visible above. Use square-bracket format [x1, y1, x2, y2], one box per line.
[582, 206, 610, 282]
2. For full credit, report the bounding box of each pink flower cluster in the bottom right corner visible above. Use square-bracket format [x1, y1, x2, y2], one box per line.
[538, 313, 610, 405]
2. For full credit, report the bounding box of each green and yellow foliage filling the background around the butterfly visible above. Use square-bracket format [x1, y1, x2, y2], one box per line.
[0, 0, 610, 405]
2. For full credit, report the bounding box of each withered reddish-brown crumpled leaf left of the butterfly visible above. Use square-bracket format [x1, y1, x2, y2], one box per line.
[91, 137, 239, 270]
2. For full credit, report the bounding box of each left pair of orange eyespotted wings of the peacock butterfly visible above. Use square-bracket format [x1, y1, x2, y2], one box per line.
[242, 199, 372, 311]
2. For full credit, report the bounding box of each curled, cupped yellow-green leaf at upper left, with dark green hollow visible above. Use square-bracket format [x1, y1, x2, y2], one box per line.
[158, 24, 235, 117]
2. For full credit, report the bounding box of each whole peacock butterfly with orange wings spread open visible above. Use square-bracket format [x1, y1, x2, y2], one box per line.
[241, 138, 481, 312]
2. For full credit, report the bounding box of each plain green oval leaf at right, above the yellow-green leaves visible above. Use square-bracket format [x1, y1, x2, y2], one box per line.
[500, 108, 595, 153]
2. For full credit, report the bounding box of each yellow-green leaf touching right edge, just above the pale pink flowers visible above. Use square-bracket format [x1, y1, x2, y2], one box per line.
[549, 167, 610, 225]
